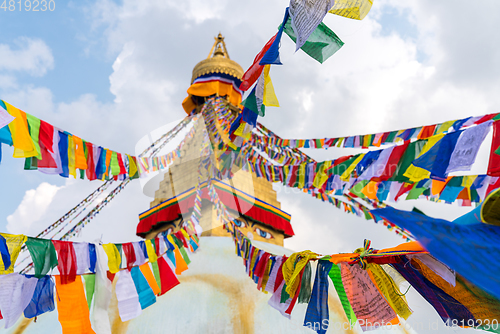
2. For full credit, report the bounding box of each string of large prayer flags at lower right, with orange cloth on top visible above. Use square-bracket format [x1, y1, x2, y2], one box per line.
[226, 217, 500, 333]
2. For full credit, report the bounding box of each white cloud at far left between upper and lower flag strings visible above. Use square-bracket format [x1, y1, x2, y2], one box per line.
[7, 182, 61, 234]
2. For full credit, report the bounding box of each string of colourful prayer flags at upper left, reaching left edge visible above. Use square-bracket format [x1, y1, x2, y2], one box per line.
[0, 100, 141, 180]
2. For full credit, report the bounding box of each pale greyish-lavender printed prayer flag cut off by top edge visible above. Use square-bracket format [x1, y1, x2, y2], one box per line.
[290, 0, 335, 51]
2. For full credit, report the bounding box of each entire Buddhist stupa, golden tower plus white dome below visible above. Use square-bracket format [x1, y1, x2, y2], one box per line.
[5, 34, 357, 334]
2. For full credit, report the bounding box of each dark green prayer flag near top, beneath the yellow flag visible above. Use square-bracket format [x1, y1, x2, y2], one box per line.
[284, 18, 344, 63]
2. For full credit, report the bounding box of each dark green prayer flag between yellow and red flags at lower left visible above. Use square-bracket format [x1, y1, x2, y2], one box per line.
[26, 237, 59, 278]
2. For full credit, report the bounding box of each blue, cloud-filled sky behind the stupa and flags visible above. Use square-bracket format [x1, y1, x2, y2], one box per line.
[0, 0, 500, 333]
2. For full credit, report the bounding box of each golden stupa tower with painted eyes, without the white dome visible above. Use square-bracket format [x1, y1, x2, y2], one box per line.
[137, 34, 293, 246]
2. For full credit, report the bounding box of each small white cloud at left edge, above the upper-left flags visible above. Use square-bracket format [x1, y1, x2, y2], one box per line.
[0, 37, 54, 76]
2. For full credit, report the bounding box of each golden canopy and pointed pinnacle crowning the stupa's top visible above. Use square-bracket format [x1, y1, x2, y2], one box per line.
[191, 33, 244, 83]
